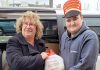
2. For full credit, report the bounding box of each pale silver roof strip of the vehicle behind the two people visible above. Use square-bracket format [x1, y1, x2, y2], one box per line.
[0, 7, 100, 18]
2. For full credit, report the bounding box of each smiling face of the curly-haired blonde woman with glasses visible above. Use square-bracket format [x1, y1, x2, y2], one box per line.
[22, 18, 36, 37]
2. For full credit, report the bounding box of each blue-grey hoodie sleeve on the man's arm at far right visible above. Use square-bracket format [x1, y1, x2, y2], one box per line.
[70, 33, 99, 70]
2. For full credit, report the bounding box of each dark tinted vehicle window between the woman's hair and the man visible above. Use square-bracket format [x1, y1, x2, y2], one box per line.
[41, 20, 58, 42]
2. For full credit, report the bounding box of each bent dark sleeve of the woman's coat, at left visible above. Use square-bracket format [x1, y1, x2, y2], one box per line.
[6, 38, 44, 70]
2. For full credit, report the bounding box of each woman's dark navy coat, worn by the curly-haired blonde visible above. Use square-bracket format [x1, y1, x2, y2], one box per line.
[6, 33, 45, 70]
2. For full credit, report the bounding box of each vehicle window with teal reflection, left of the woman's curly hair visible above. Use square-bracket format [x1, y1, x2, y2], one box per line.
[0, 19, 15, 36]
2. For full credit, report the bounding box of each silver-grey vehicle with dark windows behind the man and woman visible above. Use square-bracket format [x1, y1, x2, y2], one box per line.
[0, 8, 100, 69]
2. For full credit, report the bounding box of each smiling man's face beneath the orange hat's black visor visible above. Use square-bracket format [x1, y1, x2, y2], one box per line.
[66, 15, 83, 34]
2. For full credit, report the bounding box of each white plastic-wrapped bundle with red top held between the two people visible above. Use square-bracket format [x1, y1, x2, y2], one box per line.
[45, 50, 64, 70]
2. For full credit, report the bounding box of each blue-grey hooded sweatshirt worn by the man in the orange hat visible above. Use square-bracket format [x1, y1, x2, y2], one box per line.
[60, 23, 99, 70]
